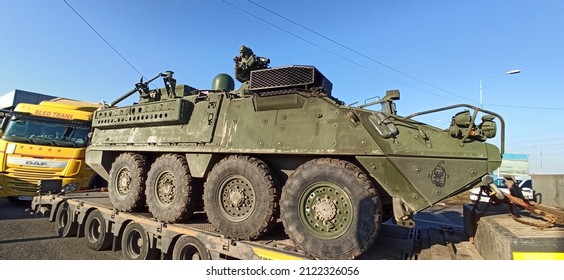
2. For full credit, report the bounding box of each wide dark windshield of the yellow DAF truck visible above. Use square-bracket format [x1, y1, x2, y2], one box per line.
[2, 116, 90, 148]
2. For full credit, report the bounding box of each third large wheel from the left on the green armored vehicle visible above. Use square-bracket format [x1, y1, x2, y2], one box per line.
[204, 156, 279, 240]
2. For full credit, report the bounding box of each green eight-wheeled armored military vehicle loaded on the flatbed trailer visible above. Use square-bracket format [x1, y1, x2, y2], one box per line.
[86, 46, 504, 259]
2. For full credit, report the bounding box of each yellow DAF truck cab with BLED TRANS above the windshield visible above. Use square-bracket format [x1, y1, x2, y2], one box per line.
[0, 98, 105, 202]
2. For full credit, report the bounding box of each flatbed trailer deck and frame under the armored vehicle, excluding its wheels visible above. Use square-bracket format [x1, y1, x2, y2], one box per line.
[32, 192, 481, 260]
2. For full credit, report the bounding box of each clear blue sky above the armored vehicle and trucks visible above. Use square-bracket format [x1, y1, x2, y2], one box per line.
[0, 0, 564, 174]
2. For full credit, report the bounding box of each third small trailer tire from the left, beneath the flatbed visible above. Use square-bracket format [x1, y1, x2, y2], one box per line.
[121, 222, 158, 260]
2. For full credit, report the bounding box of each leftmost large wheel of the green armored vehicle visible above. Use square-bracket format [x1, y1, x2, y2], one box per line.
[108, 153, 147, 212]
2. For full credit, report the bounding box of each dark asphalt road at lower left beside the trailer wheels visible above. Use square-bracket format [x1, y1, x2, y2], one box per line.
[0, 198, 121, 260]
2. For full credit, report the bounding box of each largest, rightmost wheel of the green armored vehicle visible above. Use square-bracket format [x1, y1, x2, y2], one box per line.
[280, 158, 382, 259]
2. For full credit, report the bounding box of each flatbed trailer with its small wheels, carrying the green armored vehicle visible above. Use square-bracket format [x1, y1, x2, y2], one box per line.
[31, 192, 481, 260]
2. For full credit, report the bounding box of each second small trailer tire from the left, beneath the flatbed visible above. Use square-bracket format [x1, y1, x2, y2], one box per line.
[84, 210, 112, 251]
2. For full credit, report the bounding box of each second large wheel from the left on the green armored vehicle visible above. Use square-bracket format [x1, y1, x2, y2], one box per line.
[145, 154, 194, 223]
